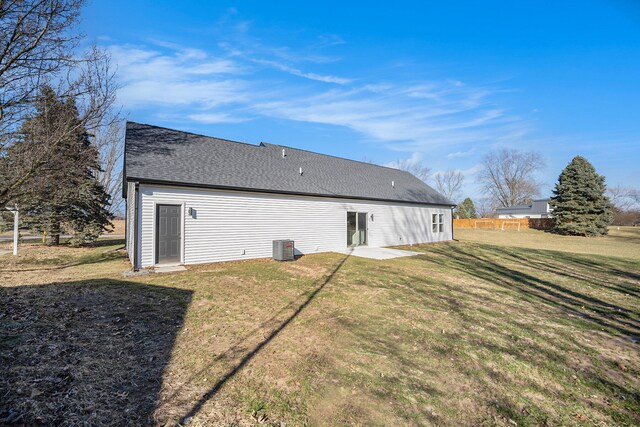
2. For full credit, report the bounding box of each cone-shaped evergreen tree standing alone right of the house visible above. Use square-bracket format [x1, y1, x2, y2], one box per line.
[549, 156, 613, 236]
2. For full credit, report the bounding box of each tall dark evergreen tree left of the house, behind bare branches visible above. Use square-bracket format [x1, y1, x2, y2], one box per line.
[9, 86, 112, 245]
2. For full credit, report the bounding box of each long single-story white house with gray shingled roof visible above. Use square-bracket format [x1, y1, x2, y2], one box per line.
[123, 122, 453, 269]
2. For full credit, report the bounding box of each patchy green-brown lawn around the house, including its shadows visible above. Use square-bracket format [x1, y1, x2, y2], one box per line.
[0, 229, 640, 426]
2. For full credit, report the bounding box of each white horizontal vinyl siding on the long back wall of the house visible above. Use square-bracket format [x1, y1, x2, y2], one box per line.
[140, 184, 451, 267]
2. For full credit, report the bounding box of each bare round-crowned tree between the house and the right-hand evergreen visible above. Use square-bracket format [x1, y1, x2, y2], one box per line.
[480, 148, 544, 207]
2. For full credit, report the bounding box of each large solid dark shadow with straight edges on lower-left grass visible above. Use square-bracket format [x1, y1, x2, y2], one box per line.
[0, 279, 192, 425]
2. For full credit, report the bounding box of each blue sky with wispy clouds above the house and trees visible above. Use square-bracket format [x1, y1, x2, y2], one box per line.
[82, 0, 640, 201]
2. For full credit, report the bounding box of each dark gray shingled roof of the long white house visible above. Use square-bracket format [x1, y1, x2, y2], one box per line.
[124, 122, 452, 205]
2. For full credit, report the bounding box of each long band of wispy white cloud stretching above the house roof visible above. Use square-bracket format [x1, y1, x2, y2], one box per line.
[109, 28, 529, 150]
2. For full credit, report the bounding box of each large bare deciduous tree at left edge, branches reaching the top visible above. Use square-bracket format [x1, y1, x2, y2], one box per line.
[0, 0, 117, 206]
